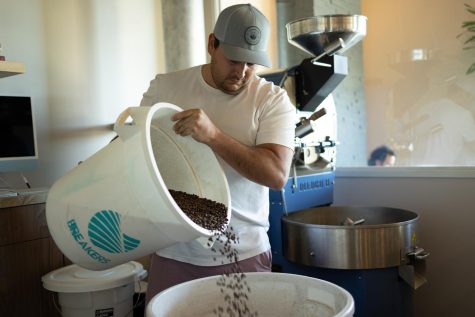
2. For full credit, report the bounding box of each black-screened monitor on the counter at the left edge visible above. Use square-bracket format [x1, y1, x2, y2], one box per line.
[0, 96, 38, 172]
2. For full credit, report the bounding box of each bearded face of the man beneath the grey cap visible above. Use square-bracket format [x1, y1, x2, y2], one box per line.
[208, 36, 256, 95]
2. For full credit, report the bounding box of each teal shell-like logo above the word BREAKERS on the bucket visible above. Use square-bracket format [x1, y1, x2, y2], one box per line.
[87, 210, 140, 253]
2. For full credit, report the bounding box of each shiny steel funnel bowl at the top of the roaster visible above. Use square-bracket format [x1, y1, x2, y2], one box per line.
[286, 14, 367, 56]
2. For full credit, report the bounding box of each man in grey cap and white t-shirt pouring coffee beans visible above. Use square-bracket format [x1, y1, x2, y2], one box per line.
[141, 4, 295, 302]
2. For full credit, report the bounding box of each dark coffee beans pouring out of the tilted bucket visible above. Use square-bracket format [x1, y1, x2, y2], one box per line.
[169, 189, 258, 317]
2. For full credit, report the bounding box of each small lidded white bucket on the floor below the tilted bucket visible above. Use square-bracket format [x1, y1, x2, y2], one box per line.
[42, 261, 147, 317]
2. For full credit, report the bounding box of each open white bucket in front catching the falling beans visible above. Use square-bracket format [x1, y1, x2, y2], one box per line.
[146, 272, 355, 317]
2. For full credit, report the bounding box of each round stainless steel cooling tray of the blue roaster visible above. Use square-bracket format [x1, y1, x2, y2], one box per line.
[282, 206, 419, 269]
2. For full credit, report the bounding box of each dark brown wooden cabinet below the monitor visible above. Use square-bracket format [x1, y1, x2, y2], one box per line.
[0, 193, 66, 317]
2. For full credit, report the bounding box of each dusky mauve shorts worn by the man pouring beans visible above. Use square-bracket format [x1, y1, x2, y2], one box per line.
[145, 250, 272, 304]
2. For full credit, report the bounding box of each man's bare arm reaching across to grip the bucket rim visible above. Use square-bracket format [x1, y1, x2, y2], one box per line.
[172, 109, 293, 190]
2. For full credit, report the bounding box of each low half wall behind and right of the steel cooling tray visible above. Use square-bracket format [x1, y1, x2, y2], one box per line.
[335, 172, 475, 317]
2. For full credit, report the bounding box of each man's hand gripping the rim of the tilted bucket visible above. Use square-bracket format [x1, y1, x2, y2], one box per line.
[171, 109, 218, 144]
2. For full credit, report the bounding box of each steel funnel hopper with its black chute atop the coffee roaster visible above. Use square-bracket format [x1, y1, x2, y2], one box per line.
[286, 15, 367, 111]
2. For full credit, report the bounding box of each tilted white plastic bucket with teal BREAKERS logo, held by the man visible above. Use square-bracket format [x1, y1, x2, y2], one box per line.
[46, 103, 231, 270]
